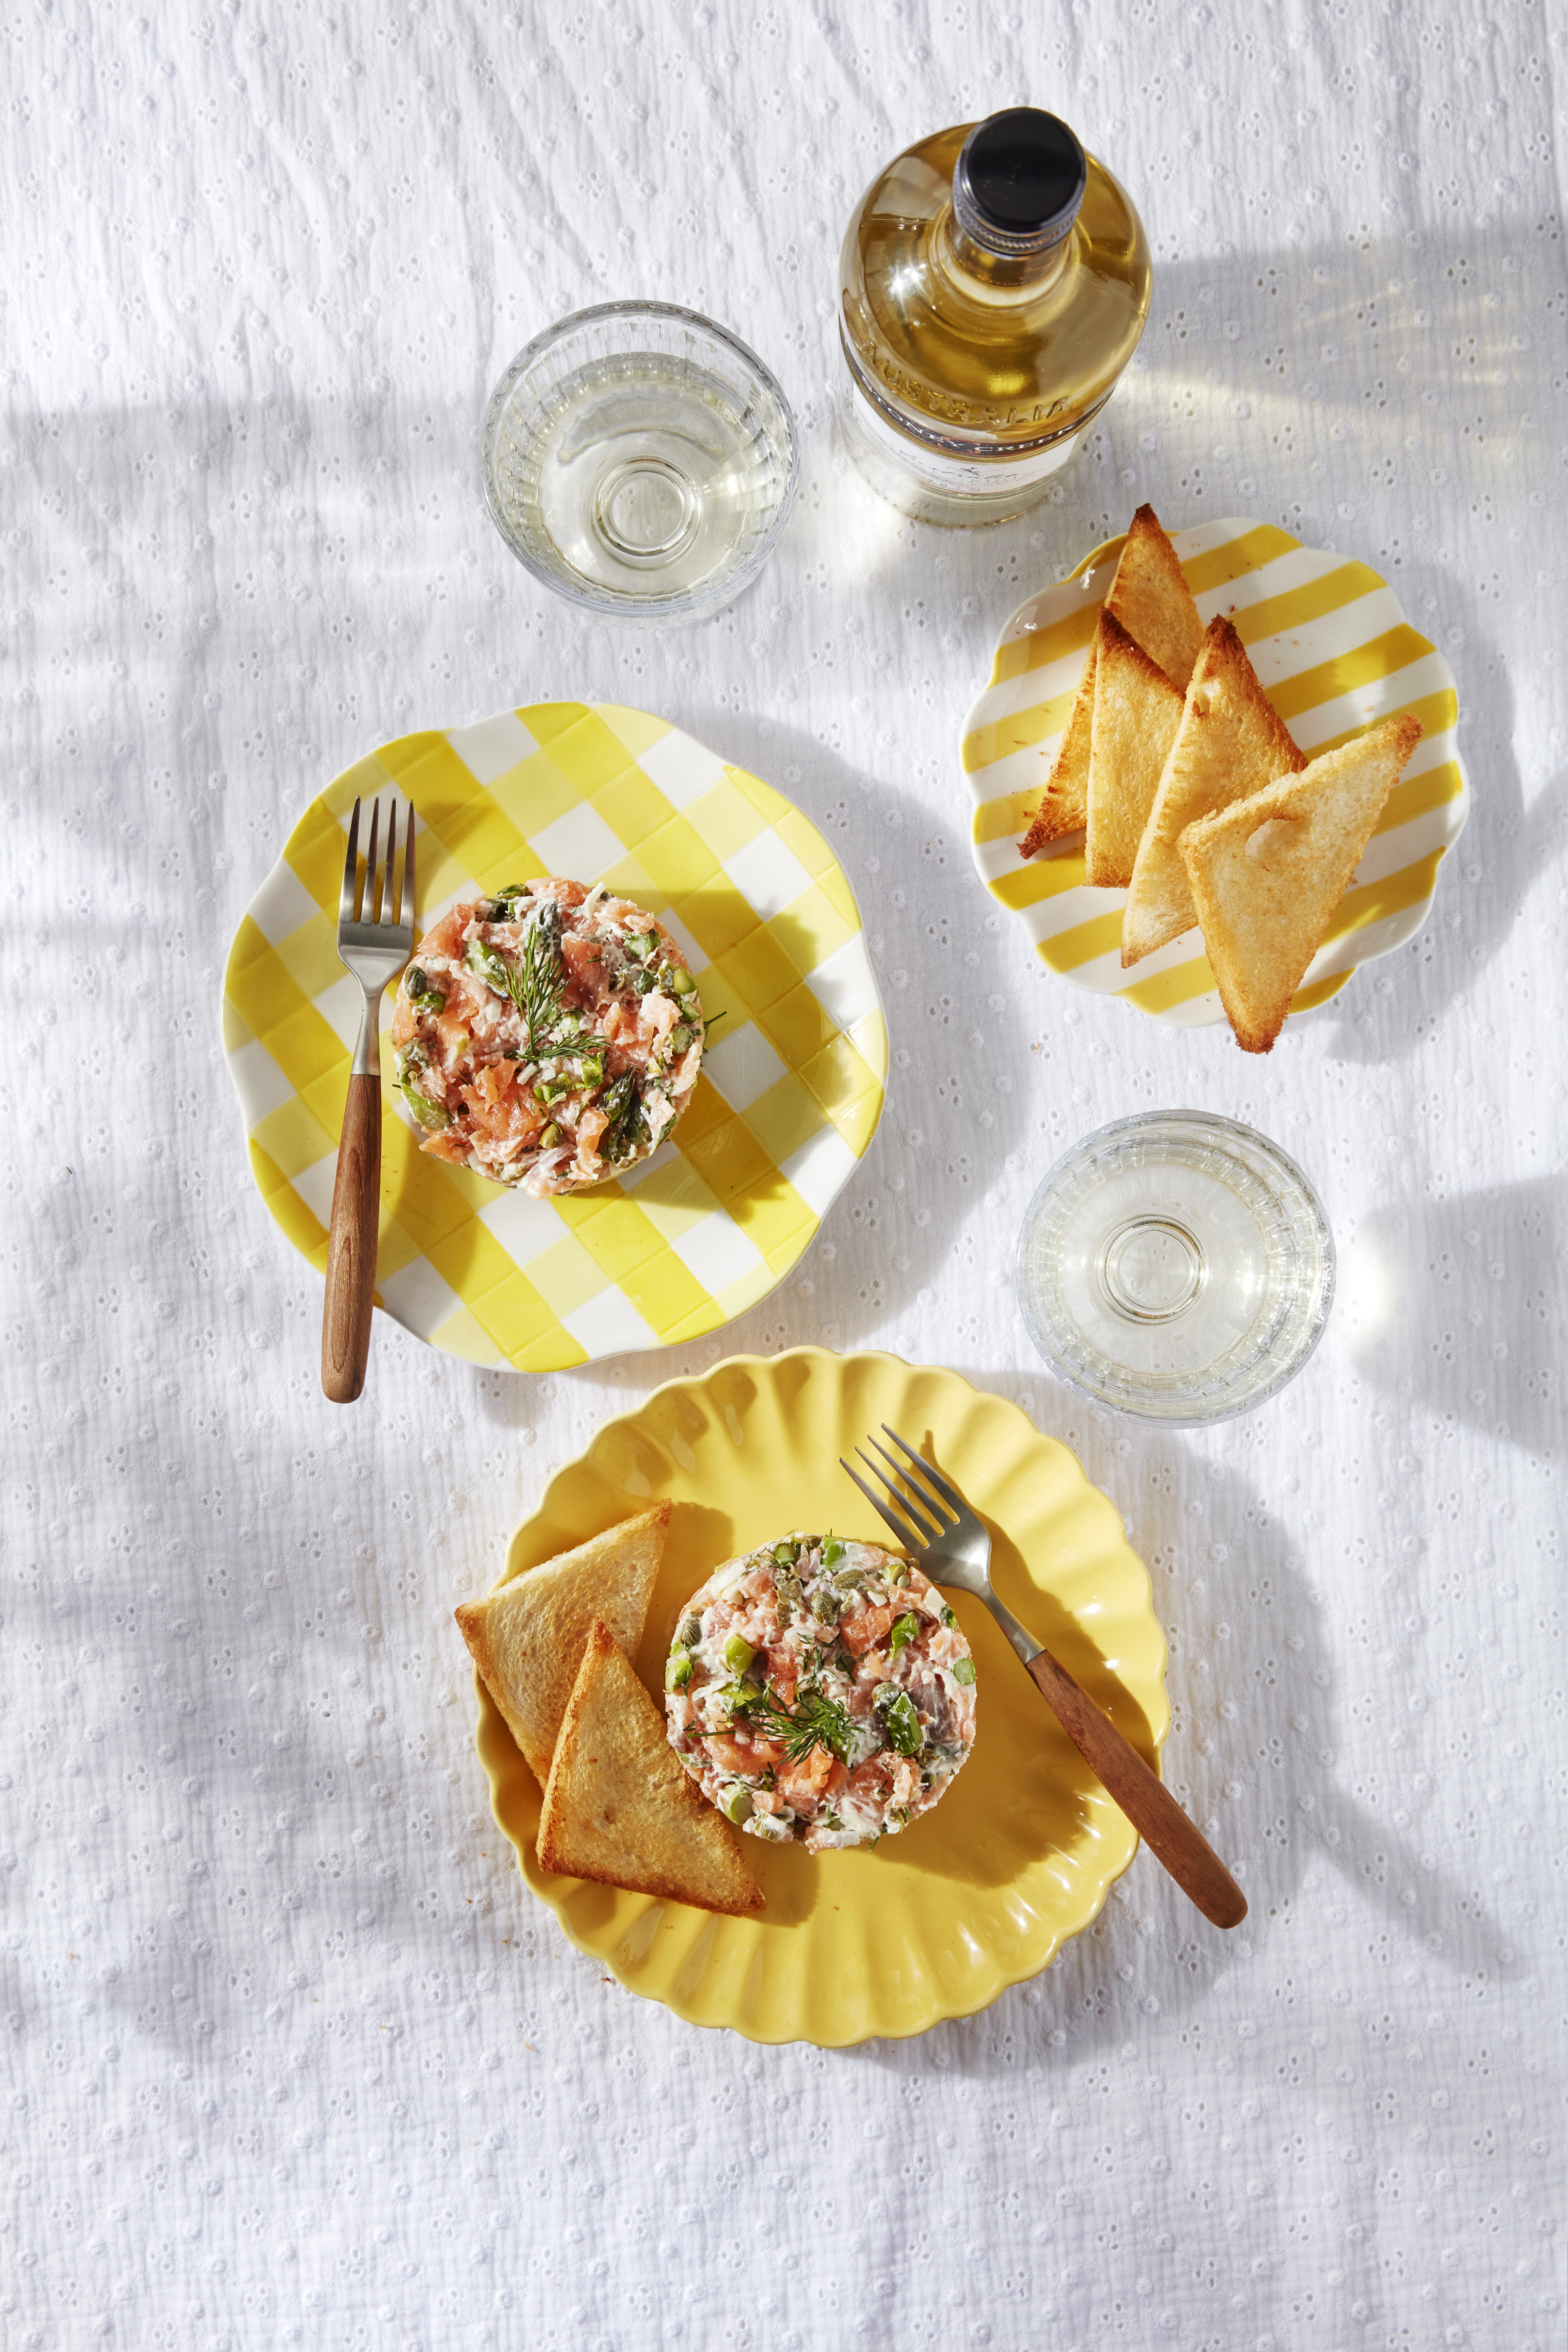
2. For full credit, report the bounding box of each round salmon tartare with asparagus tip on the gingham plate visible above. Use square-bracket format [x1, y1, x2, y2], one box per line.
[392, 875, 703, 1197]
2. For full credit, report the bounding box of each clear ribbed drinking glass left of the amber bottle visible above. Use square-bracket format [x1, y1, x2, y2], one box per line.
[482, 301, 799, 623]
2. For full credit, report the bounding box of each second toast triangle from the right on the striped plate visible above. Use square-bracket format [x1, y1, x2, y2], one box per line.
[1121, 619, 1307, 969]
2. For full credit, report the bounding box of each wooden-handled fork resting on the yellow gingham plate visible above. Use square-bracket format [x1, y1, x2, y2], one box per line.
[322, 797, 414, 1404]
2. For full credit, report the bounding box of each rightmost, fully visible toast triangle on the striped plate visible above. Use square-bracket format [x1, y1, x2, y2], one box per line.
[1176, 718, 1420, 1054]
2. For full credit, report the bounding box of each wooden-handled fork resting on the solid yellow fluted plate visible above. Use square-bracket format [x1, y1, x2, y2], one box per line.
[839, 1421, 1246, 1926]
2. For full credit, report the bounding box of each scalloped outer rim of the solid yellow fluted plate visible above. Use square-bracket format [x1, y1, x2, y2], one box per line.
[473, 1341, 1173, 2049]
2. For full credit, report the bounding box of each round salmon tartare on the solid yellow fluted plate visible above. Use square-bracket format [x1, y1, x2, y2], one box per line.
[665, 1536, 976, 1853]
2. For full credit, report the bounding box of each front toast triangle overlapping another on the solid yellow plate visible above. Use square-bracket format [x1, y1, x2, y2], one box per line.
[538, 1623, 764, 1919]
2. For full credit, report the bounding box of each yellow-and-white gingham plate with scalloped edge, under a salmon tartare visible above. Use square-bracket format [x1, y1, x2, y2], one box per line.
[223, 703, 889, 1372]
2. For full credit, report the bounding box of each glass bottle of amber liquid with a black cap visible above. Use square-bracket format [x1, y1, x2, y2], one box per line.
[839, 108, 1150, 522]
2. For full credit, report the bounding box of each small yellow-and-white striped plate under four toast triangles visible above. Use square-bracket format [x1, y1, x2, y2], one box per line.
[964, 520, 1469, 1028]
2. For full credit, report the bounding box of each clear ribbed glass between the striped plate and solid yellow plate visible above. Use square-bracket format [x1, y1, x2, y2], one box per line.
[1018, 1110, 1333, 1425]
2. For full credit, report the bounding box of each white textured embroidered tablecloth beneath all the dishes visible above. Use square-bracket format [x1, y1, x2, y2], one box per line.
[0, 0, 1568, 2352]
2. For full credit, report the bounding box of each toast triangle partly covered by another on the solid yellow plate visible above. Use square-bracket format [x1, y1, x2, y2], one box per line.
[453, 1503, 670, 1788]
